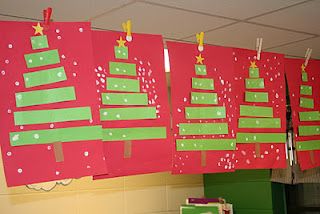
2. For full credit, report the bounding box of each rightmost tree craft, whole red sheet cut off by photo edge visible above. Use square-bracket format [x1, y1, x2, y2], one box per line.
[285, 59, 320, 170]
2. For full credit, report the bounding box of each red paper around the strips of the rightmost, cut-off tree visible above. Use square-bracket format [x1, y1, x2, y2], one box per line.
[285, 59, 320, 170]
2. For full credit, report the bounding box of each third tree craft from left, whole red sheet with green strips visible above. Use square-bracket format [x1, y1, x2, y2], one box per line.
[167, 42, 237, 174]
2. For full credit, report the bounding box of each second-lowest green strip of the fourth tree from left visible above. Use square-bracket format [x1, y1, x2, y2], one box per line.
[239, 118, 281, 128]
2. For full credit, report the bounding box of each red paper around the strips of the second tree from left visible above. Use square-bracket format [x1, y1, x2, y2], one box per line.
[93, 31, 171, 179]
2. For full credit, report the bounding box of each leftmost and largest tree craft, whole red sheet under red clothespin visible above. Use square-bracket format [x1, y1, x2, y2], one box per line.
[0, 21, 106, 186]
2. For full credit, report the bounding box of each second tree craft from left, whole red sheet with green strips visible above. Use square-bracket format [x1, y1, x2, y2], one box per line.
[93, 31, 171, 179]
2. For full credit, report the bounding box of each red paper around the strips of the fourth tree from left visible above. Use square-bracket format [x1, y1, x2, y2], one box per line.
[233, 49, 286, 169]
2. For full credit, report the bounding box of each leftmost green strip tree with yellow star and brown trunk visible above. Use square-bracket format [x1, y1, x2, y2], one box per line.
[10, 23, 101, 162]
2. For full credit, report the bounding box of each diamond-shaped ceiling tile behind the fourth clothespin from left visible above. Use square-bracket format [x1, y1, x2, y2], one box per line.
[184, 23, 310, 49]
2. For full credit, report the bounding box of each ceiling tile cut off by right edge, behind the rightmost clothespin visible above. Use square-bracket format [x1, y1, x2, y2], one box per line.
[268, 37, 320, 59]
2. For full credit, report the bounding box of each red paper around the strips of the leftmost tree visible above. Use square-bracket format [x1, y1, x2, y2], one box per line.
[0, 21, 106, 186]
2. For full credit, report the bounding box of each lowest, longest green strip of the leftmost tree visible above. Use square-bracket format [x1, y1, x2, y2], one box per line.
[10, 126, 102, 146]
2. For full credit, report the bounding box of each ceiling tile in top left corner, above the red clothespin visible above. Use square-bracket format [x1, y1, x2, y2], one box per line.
[0, 0, 129, 21]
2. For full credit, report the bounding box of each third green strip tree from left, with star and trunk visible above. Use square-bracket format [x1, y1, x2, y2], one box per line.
[176, 54, 235, 167]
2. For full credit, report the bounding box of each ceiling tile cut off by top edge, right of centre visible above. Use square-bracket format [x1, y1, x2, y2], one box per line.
[147, 0, 303, 19]
